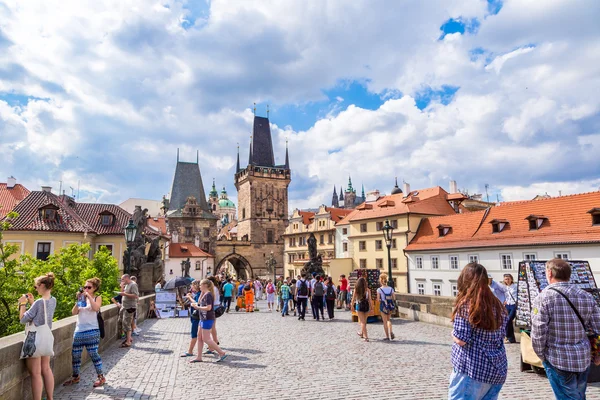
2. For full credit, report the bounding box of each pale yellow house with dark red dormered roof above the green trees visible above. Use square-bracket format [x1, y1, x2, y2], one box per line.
[3, 187, 131, 269]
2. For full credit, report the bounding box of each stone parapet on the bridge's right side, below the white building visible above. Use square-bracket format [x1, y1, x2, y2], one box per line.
[396, 293, 454, 327]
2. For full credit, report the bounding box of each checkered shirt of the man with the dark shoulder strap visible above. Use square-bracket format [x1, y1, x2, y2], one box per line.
[531, 282, 600, 372]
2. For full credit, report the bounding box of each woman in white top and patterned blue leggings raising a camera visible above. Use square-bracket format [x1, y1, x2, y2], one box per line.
[63, 278, 106, 387]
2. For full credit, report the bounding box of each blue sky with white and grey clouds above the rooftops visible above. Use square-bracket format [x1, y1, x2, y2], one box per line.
[0, 0, 600, 211]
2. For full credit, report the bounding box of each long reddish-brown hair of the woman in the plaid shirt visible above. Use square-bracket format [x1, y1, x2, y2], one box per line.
[452, 263, 506, 331]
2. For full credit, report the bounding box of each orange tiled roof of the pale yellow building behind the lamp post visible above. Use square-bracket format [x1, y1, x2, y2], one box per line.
[348, 186, 455, 221]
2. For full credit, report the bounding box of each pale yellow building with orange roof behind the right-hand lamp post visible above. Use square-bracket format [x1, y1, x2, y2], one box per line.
[337, 186, 464, 293]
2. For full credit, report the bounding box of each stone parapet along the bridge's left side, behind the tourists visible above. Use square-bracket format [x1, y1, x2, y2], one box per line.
[0, 295, 154, 400]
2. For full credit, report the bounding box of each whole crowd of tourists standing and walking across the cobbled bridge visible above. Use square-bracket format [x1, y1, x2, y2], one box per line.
[18, 259, 600, 400]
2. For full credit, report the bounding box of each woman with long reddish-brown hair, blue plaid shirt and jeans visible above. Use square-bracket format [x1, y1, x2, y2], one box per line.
[448, 263, 508, 400]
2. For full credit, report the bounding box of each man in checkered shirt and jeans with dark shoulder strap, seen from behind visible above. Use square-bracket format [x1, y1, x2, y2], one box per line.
[531, 259, 600, 399]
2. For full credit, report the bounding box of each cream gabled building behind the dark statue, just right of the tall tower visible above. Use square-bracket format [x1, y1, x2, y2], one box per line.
[283, 205, 352, 277]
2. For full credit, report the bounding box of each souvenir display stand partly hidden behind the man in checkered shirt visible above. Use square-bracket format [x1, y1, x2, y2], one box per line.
[515, 260, 600, 382]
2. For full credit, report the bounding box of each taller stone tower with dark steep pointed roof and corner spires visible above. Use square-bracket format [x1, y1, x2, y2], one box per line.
[235, 115, 291, 250]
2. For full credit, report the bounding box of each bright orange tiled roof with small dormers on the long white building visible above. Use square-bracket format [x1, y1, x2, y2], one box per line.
[406, 192, 600, 251]
